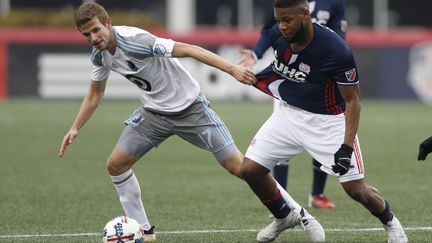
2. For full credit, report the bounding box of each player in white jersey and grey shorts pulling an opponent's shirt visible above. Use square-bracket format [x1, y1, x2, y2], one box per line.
[59, 3, 323, 242]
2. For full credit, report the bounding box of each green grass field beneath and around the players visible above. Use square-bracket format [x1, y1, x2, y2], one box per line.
[0, 99, 432, 242]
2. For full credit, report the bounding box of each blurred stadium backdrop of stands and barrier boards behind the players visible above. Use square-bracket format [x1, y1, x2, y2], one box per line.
[0, 0, 432, 101]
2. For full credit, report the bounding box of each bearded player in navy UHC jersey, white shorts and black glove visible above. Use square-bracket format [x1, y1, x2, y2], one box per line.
[241, 0, 408, 242]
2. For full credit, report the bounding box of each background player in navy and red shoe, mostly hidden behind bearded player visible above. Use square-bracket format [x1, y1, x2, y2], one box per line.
[240, 0, 347, 208]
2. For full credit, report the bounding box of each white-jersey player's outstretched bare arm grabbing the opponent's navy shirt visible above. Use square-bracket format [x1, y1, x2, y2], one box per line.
[172, 42, 257, 85]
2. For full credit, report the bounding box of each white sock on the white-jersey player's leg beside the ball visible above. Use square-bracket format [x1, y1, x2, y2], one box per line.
[111, 169, 151, 230]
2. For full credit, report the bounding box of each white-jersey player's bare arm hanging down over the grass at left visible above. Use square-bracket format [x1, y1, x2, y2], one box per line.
[58, 80, 106, 157]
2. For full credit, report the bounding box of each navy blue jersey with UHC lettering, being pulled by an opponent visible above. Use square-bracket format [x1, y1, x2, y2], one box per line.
[255, 23, 359, 114]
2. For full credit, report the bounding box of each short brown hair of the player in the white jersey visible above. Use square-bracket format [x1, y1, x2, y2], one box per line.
[74, 2, 108, 29]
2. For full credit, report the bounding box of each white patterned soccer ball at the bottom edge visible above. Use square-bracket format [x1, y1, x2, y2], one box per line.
[102, 216, 144, 243]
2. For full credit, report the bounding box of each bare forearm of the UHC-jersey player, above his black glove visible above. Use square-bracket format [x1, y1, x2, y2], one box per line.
[338, 84, 361, 147]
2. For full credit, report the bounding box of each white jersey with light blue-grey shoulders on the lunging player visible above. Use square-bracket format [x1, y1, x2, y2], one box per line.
[91, 26, 200, 113]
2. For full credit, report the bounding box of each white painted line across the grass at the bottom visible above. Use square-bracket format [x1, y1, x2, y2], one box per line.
[0, 226, 432, 239]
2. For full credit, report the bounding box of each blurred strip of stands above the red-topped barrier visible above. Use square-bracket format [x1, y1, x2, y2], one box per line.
[0, 0, 432, 28]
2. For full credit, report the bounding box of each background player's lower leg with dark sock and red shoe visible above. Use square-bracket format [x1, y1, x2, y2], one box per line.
[308, 159, 336, 208]
